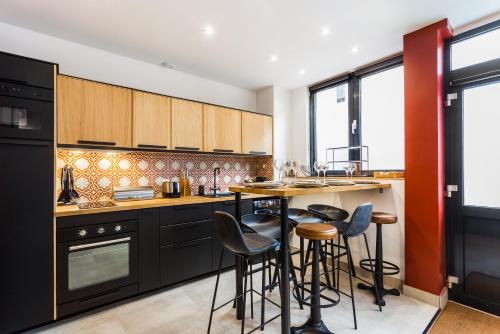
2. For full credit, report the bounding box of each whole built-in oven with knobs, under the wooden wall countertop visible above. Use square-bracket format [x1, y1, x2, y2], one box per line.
[56, 220, 138, 317]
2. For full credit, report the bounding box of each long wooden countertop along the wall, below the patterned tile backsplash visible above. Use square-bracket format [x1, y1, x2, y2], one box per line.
[55, 194, 266, 217]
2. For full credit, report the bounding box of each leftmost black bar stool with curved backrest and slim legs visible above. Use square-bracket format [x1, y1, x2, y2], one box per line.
[207, 211, 280, 334]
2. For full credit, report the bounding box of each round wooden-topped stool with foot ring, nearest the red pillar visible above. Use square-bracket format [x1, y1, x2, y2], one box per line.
[358, 212, 400, 306]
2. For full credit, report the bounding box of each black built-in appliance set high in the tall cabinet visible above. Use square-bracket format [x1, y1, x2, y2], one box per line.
[0, 81, 54, 140]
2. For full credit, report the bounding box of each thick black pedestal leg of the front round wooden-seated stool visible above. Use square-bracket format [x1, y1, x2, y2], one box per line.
[291, 240, 332, 334]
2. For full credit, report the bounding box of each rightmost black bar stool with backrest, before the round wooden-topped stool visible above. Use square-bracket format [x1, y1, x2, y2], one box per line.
[316, 203, 382, 329]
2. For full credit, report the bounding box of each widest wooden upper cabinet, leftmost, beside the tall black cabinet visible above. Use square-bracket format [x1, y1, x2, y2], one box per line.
[57, 76, 132, 147]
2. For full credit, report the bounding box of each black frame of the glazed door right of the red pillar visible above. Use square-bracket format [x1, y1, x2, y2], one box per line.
[443, 20, 500, 314]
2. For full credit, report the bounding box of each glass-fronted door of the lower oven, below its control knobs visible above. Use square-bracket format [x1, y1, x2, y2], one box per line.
[57, 232, 138, 304]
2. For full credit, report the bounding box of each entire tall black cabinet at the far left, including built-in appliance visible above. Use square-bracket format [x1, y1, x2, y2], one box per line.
[0, 53, 54, 333]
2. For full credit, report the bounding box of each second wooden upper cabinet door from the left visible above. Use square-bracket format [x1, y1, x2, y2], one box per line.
[132, 91, 171, 149]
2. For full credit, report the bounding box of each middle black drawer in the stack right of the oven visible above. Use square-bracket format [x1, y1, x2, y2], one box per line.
[160, 220, 213, 246]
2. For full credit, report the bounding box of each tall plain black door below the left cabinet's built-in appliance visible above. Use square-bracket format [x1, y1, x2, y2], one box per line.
[0, 140, 54, 333]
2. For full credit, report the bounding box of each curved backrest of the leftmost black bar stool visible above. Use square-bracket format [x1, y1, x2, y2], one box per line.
[214, 211, 249, 254]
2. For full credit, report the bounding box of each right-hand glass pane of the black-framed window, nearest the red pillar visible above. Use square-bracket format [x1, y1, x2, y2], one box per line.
[360, 66, 404, 170]
